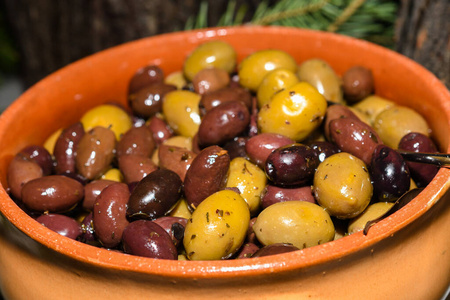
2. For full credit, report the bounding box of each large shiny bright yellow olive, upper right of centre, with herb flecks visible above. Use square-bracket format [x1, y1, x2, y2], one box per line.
[258, 82, 327, 141]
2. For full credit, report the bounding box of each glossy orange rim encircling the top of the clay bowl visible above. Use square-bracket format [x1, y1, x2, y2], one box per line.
[0, 25, 450, 278]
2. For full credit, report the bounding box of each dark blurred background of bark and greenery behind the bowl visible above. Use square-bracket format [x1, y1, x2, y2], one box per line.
[0, 0, 450, 111]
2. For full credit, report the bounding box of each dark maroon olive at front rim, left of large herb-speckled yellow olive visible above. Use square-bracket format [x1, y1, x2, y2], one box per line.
[122, 220, 178, 260]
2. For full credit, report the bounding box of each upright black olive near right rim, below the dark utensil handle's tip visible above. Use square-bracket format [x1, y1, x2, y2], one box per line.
[370, 145, 411, 201]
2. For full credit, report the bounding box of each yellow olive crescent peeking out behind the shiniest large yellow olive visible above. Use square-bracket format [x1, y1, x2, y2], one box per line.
[256, 69, 298, 108]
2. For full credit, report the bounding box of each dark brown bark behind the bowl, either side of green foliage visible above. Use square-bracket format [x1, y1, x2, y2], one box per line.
[0, 0, 450, 87]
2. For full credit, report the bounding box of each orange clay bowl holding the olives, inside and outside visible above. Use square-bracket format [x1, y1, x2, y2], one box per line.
[0, 26, 450, 300]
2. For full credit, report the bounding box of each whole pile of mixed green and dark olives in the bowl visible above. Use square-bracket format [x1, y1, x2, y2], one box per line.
[7, 40, 438, 260]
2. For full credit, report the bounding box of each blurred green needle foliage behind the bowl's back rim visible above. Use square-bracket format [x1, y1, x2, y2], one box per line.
[185, 0, 398, 47]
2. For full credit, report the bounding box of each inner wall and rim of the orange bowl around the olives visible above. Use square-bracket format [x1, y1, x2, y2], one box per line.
[0, 26, 450, 276]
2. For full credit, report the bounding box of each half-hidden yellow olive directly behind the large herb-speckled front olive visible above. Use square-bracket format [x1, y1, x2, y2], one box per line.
[227, 157, 267, 215]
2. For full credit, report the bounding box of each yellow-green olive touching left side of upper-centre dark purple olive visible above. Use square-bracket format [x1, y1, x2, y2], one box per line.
[162, 90, 201, 138]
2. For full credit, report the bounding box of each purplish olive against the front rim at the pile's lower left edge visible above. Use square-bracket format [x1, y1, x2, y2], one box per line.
[36, 214, 83, 240]
